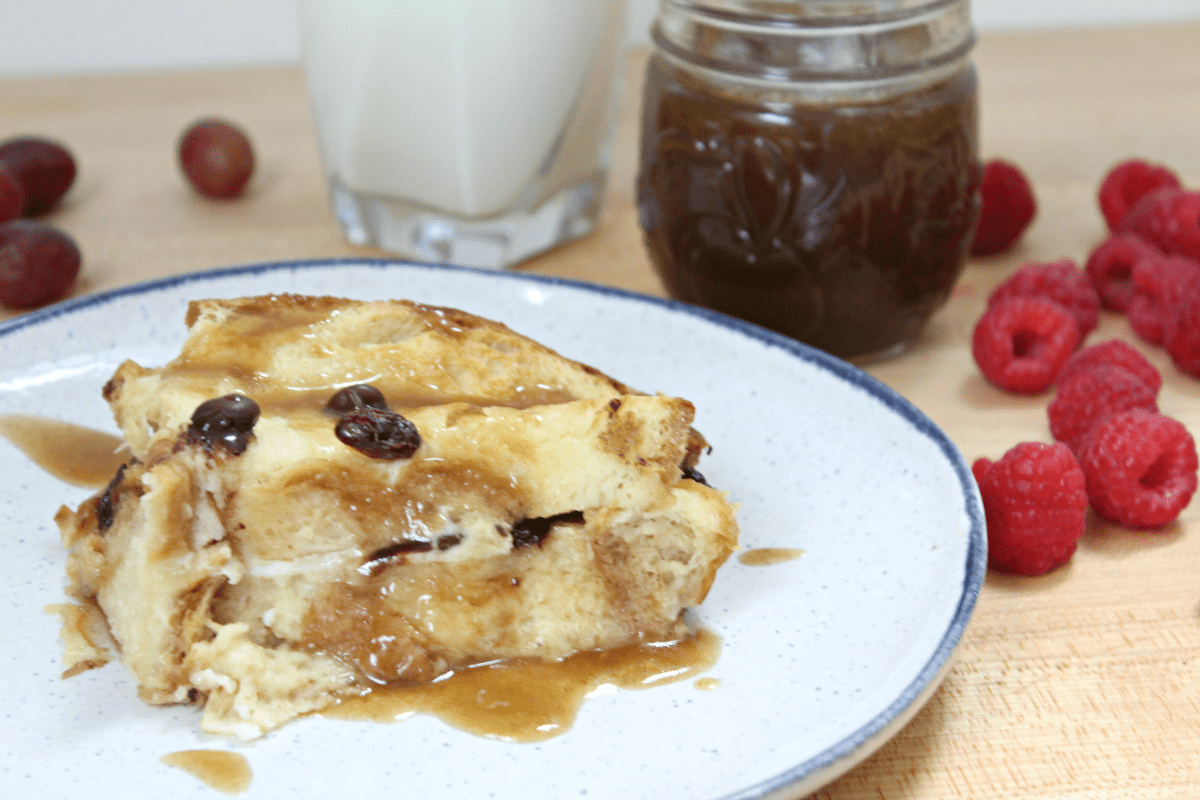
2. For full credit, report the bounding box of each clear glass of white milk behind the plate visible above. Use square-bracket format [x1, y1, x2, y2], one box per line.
[300, 0, 625, 267]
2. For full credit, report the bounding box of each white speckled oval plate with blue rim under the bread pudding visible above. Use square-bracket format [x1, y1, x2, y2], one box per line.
[0, 261, 986, 800]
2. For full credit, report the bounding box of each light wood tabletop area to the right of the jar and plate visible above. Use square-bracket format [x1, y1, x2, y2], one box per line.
[815, 21, 1200, 800]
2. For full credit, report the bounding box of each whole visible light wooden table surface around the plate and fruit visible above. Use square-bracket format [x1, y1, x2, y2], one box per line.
[0, 24, 1200, 800]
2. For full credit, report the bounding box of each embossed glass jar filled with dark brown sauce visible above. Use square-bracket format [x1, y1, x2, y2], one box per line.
[637, 0, 980, 360]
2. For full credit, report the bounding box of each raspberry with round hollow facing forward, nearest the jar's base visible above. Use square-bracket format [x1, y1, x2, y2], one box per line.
[971, 297, 1081, 395]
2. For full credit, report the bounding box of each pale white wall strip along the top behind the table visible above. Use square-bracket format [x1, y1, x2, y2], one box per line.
[0, 0, 1200, 76]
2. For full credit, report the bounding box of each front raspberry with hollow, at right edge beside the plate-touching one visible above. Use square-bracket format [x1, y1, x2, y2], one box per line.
[1079, 410, 1198, 528]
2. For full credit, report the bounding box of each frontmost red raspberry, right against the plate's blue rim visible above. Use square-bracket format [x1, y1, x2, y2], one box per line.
[971, 441, 1087, 575]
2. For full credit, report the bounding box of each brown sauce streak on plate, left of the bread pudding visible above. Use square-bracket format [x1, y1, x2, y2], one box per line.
[0, 414, 130, 488]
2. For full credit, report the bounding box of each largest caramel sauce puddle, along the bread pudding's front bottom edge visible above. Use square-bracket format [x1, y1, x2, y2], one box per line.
[322, 627, 721, 742]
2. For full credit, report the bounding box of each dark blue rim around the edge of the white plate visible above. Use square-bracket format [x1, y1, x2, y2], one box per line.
[0, 258, 986, 800]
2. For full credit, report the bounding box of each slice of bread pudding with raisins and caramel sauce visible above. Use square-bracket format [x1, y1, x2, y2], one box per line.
[56, 295, 737, 739]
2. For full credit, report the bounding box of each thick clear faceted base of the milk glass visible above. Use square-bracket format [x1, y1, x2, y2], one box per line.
[330, 172, 606, 269]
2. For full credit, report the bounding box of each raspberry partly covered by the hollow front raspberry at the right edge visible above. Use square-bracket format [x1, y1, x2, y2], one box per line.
[1046, 366, 1158, 451]
